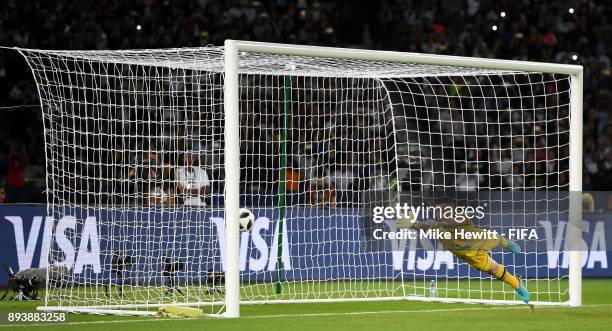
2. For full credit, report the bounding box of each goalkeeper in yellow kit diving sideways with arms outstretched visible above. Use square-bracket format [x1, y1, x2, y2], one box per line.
[398, 198, 529, 303]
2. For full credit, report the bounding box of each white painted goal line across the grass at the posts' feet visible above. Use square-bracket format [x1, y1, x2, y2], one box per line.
[0, 304, 612, 328]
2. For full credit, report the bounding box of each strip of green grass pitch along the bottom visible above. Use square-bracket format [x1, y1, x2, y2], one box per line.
[0, 279, 612, 331]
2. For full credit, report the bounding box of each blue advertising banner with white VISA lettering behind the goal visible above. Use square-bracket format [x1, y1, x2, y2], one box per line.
[0, 205, 612, 283]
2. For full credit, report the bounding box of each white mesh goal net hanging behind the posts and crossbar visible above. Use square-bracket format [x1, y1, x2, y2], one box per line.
[19, 41, 581, 316]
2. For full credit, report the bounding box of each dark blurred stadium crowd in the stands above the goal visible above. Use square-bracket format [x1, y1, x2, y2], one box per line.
[0, 0, 612, 203]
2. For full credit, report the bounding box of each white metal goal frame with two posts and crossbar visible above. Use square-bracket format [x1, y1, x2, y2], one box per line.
[224, 40, 583, 318]
